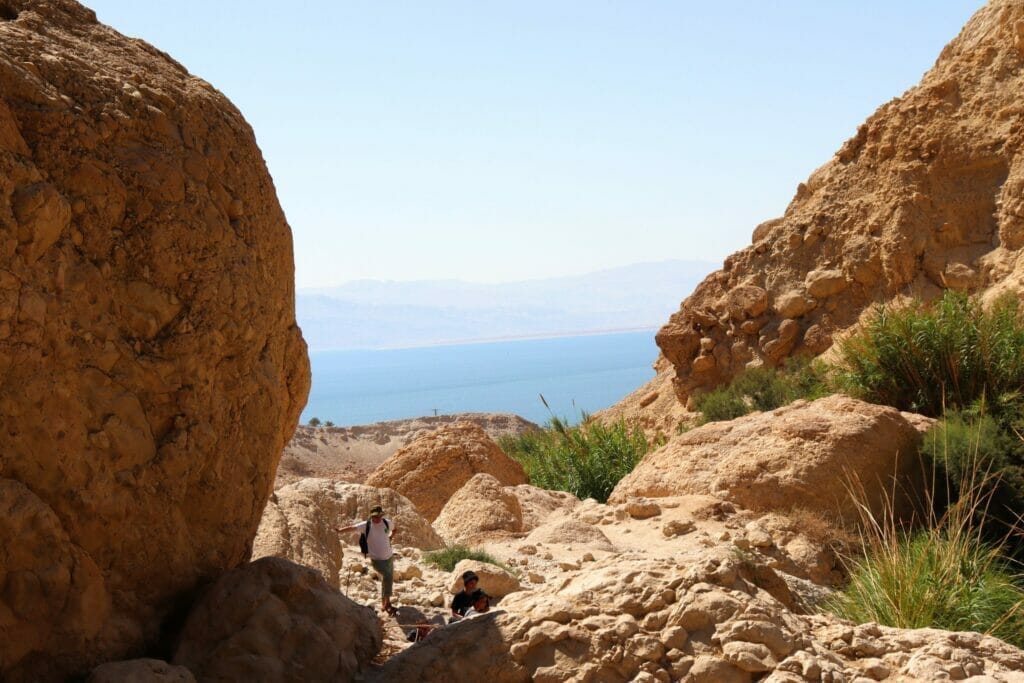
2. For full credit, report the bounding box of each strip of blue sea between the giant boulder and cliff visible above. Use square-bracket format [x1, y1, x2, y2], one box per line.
[301, 331, 657, 426]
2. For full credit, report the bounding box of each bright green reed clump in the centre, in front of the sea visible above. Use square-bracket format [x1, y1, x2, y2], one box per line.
[499, 416, 660, 503]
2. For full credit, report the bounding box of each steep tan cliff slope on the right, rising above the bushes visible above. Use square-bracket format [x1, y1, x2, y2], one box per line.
[657, 0, 1024, 402]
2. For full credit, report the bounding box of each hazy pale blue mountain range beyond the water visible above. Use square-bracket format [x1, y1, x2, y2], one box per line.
[296, 260, 718, 351]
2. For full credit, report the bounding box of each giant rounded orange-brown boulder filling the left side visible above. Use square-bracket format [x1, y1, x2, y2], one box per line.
[0, 0, 309, 681]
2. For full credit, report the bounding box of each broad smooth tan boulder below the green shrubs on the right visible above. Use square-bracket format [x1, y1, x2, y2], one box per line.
[608, 394, 928, 521]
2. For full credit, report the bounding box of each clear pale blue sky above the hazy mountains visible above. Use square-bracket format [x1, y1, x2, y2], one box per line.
[86, 0, 981, 287]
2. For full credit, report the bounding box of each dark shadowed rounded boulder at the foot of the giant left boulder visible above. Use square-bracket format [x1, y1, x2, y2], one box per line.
[173, 557, 382, 683]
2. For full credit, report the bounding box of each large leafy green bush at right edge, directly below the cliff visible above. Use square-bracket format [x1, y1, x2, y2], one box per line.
[837, 291, 1024, 416]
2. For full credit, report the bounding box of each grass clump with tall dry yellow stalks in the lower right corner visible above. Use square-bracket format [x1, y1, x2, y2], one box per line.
[824, 472, 1024, 647]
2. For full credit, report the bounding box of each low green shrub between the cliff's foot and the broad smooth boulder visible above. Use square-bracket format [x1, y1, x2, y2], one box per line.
[696, 356, 828, 424]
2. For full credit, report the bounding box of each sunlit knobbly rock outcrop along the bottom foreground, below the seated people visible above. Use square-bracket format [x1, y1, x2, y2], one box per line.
[370, 547, 1024, 683]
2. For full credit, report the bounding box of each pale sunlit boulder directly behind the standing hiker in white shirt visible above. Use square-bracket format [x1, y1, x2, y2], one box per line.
[253, 479, 444, 588]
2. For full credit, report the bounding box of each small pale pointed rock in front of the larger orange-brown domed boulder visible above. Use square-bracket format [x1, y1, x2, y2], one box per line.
[433, 473, 522, 544]
